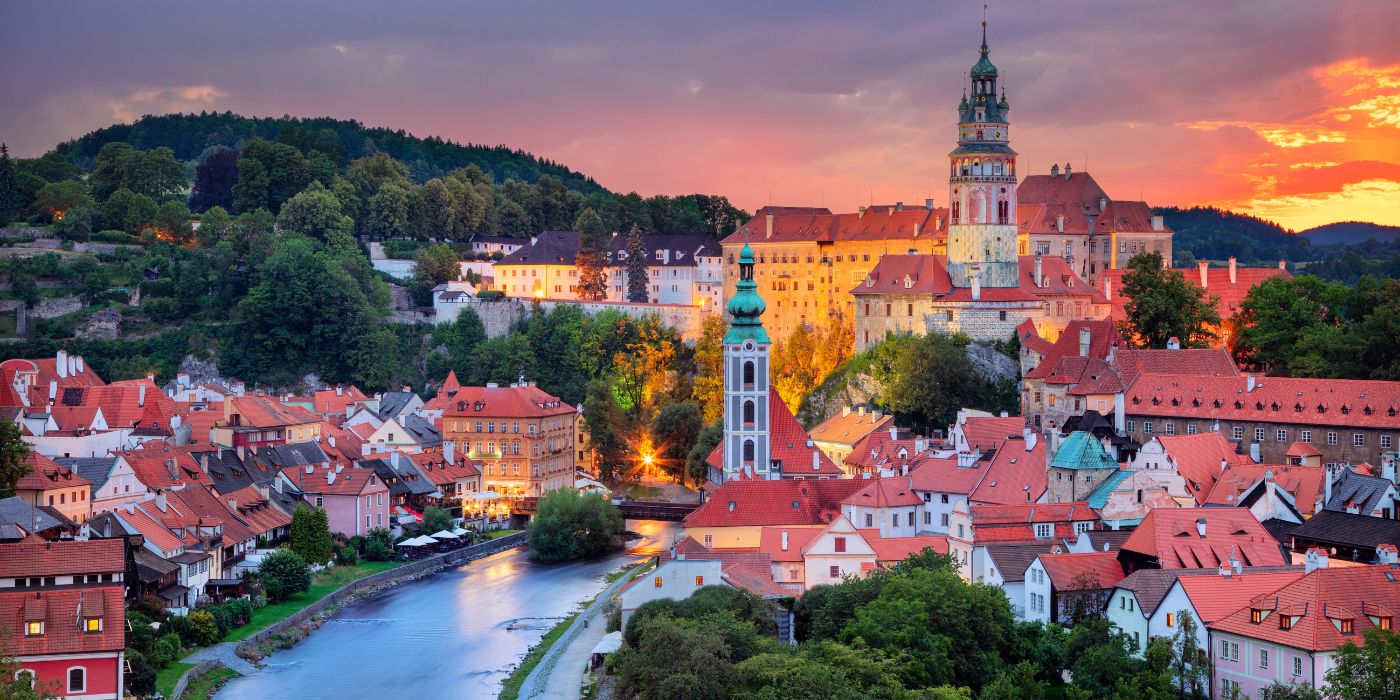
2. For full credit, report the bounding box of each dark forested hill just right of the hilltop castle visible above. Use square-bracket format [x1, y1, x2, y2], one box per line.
[1156, 207, 1312, 266]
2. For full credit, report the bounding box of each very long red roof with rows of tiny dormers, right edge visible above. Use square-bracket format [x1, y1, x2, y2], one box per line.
[1126, 375, 1400, 428]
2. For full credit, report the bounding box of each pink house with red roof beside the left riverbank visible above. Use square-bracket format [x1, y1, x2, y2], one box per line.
[281, 465, 391, 536]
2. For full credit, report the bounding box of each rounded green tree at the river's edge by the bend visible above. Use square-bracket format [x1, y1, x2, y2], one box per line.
[529, 489, 623, 561]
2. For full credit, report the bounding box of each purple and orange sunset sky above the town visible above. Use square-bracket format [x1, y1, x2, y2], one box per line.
[0, 0, 1400, 228]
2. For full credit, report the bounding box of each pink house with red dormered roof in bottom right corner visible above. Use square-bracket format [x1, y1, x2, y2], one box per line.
[1210, 545, 1400, 697]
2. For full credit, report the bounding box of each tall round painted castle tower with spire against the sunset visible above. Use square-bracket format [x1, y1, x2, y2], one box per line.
[948, 18, 1018, 287]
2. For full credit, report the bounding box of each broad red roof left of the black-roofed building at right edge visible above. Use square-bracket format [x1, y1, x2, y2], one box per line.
[1123, 508, 1287, 568]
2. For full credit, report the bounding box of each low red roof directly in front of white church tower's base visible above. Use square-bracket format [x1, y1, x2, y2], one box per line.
[685, 479, 867, 528]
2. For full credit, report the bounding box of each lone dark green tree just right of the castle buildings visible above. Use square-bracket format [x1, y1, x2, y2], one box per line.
[1123, 252, 1221, 347]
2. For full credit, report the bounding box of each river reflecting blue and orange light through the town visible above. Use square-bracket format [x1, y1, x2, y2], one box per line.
[214, 521, 679, 700]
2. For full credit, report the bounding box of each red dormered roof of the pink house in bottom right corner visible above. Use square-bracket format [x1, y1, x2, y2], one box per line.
[1210, 566, 1400, 651]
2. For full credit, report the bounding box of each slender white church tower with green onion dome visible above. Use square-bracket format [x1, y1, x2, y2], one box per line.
[724, 231, 780, 480]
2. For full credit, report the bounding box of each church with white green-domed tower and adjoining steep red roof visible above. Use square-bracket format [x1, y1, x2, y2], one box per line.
[708, 238, 841, 484]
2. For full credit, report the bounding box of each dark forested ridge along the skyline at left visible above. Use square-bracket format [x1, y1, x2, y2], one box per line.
[55, 112, 603, 195]
